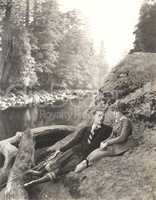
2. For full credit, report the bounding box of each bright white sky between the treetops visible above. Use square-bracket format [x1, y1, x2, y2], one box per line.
[59, 0, 143, 67]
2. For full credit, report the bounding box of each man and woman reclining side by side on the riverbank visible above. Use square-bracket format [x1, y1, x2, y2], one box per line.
[25, 103, 132, 187]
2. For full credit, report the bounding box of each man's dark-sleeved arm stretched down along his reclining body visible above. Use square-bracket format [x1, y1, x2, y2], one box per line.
[60, 127, 87, 152]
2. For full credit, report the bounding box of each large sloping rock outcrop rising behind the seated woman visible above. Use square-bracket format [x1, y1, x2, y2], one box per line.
[96, 53, 156, 127]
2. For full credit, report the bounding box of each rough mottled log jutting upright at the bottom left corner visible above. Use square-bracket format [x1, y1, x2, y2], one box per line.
[5, 129, 35, 200]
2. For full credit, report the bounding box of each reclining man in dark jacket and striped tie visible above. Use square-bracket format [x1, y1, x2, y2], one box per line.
[25, 107, 112, 187]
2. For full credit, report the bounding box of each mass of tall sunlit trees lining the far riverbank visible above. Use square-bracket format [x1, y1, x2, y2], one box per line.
[1, 0, 107, 91]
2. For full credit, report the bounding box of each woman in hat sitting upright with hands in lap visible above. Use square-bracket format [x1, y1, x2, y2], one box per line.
[75, 102, 132, 172]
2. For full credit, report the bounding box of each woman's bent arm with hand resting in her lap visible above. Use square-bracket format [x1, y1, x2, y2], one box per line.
[106, 119, 130, 145]
